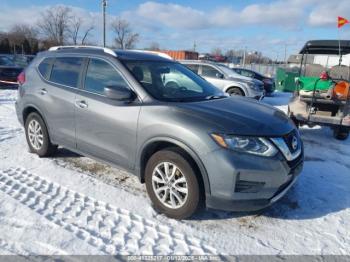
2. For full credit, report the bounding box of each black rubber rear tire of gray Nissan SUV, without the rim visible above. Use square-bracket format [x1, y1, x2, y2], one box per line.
[24, 112, 57, 157]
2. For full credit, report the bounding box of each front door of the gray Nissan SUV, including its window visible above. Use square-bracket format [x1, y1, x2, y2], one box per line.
[75, 58, 141, 169]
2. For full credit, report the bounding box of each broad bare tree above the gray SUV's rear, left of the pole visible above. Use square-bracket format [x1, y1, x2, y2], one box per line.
[38, 6, 73, 45]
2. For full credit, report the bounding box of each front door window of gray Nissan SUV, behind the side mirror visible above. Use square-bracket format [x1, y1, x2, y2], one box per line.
[85, 59, 128, 95]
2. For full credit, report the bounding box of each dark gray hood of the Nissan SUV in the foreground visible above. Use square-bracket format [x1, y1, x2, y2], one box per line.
[177, 97, 295, 137]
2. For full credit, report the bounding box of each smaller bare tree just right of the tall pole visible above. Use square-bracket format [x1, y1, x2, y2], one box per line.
[112, 18, 139, 49]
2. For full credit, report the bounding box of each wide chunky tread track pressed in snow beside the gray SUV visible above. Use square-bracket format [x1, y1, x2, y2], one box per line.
[0, 168, 217, 255]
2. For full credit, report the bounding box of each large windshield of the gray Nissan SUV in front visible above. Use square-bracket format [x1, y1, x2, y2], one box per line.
[123, 60, 226, 102]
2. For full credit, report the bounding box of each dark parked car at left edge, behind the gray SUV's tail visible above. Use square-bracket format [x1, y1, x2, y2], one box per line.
[0, 55, 23, 87]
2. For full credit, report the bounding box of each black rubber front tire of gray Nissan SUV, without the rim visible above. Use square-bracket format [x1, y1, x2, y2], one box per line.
[145, 148, 203, 219]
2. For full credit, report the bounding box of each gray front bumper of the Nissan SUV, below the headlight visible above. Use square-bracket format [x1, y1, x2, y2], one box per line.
[204, 146, 303, 211]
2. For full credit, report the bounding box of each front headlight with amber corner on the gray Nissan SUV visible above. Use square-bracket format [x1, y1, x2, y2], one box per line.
[211, 134, 278, 157]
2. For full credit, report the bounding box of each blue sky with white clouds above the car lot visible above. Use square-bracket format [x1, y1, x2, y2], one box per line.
[0, 0, 350, 59]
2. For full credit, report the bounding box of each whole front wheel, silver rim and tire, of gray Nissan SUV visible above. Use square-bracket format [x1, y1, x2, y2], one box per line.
[145, 149, 200, 219]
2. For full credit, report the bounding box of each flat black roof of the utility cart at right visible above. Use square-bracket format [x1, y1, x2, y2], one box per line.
[300, 40, 350, 55]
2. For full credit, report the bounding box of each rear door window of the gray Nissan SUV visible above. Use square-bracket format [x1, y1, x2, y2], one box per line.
[50, 57, 83, 87]
